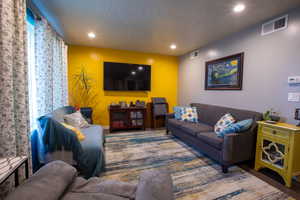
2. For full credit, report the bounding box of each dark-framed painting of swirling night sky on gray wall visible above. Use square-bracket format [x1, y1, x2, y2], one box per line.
[205, 53, 244, 90]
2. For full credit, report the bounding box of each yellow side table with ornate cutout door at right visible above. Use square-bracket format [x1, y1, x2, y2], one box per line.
[255, 121, 300, 187]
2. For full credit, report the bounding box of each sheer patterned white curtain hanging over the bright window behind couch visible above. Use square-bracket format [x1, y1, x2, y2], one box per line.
[34, 19, 68, 121]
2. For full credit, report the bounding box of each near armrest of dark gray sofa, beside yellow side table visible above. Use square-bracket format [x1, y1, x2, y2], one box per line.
[223, 131, 256, 164]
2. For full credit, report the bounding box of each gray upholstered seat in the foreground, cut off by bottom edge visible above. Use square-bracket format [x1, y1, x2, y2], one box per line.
[6, 161, 174, 200]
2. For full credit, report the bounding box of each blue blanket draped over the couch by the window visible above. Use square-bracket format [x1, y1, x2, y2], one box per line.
[31, 116, 105, 178]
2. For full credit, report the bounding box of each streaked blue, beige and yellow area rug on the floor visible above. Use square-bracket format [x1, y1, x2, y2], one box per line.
[102, 131, 292, 200]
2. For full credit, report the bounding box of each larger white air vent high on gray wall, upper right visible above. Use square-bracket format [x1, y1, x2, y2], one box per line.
[261, 15, 288, 35]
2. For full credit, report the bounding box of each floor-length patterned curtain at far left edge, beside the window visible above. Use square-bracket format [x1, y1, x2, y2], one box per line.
[0, 0, 30, 199]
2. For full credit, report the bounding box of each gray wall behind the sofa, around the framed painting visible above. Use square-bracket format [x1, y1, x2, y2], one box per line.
[178, 8, 300, 123]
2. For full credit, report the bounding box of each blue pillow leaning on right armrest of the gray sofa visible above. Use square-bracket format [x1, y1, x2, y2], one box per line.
[217, 119, 253, 137]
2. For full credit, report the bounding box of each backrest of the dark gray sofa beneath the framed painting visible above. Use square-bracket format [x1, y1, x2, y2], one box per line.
[191, 103, 262, 126]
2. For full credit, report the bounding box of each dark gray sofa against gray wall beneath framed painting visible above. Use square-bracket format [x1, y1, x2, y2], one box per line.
[166, 103, 262, 173]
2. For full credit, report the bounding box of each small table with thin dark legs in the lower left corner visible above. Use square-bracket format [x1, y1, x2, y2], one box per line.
[0, 156, 29, 187]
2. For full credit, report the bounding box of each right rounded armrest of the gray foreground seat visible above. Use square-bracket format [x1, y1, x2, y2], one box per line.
[135, 170, 174, 200]
